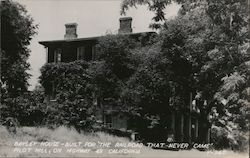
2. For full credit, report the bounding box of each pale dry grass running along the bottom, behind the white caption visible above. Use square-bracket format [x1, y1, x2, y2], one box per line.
[0, 126, 248, 158]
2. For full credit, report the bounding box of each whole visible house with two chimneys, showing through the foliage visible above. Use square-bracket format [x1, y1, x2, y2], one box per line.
[39, 17, 209, 143]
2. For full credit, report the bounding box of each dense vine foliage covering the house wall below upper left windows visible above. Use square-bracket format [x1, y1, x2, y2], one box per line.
[40, 61, 89, 102]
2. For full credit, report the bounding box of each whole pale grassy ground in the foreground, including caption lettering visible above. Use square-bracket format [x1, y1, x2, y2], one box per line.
[0, 126, 248, 158]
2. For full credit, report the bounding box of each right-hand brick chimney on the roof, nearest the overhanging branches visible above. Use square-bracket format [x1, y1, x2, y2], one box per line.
[118, 17, 132, 34]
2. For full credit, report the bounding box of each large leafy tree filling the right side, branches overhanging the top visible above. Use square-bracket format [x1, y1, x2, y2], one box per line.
[121, 0, 250, 149]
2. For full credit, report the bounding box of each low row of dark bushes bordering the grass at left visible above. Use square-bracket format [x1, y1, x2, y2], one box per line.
[0, 92, 95, 130]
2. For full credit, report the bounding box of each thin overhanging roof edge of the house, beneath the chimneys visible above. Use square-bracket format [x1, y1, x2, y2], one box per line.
[38, 31, 156, 46]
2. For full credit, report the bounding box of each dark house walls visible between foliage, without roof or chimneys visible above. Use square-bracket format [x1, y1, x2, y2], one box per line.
[40, 33, 210, 143]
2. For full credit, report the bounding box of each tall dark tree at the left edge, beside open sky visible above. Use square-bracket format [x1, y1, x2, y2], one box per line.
[0, 0, 37, 94]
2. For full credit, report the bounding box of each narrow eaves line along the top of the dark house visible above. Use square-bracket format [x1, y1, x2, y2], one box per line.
[38, 31, 157, 46]
